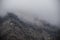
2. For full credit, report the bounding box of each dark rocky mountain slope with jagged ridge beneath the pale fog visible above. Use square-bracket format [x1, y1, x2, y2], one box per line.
[0, 13, 60, 40]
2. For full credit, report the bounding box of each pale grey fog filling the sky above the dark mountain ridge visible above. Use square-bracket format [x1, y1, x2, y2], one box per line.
[0, 0, 59, 25]
